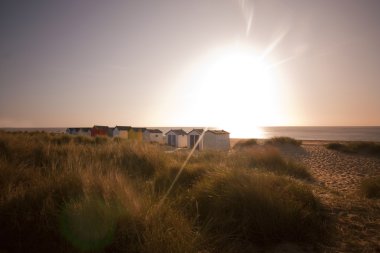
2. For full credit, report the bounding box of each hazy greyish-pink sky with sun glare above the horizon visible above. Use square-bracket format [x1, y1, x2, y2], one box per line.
[0, 0, 380, 129]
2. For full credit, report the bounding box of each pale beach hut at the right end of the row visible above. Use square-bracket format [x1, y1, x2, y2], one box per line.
[202, 130, 230, 150]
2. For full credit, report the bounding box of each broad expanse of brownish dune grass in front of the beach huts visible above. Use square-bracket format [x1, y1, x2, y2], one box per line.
[0, 132, 326, 252]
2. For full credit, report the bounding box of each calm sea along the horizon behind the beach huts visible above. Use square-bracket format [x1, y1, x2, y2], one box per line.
[0, 126, 380, 142]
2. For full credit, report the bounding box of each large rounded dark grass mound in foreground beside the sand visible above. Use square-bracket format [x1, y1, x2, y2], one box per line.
[188, 170, 324, 245]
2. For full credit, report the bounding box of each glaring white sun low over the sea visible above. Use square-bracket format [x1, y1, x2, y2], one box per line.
[183, 46, 277, 137]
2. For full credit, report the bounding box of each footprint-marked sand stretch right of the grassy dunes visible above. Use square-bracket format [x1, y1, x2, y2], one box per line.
[278, 141, 380, 252]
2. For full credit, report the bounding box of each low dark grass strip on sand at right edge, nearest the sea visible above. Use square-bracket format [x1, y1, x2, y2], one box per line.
[326, 142, 380, 158]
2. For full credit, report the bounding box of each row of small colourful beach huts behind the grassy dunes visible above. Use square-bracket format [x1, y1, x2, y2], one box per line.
[66, 125, 230, 150]
